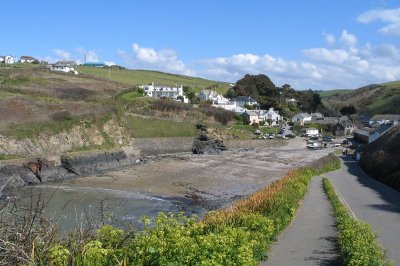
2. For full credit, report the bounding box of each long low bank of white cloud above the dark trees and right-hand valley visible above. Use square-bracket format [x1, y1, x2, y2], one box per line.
[197, 38, 400, 89]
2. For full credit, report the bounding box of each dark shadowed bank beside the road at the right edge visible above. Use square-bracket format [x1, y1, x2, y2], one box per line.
[360, 125, 400, 191]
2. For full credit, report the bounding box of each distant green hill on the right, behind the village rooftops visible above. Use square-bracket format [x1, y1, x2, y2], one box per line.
[320, 81, 400, 115]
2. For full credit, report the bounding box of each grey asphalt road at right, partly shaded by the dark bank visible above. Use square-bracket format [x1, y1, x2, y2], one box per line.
[326, 158, 400, 265]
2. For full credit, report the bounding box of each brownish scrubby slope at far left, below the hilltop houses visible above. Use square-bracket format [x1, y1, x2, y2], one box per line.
[0, 64, 128, 134]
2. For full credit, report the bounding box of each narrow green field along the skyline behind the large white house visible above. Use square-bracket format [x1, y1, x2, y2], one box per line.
[78, 66, 229, 93]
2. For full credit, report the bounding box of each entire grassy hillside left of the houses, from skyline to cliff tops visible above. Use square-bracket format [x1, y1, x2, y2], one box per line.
[0, 64, 241, 153]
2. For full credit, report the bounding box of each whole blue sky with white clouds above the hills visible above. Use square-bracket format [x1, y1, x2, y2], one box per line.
[0, 0, 400, 90]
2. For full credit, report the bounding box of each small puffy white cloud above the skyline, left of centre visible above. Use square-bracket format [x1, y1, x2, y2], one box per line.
[118, 43, 195, 75]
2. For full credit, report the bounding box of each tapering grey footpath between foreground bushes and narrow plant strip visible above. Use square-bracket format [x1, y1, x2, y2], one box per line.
[261, 177, 338, 266]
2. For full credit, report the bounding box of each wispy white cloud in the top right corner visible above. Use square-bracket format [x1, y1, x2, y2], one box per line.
[357, 8, 400, 37]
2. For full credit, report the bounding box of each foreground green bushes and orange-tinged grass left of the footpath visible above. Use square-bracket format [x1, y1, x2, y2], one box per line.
[0, 155, 340, 265]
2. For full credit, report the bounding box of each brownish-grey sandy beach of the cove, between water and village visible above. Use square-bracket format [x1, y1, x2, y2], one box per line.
[60, 138, 333, 209]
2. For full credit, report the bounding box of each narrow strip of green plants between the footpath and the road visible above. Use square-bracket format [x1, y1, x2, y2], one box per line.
[322, 178, 392, 265]
